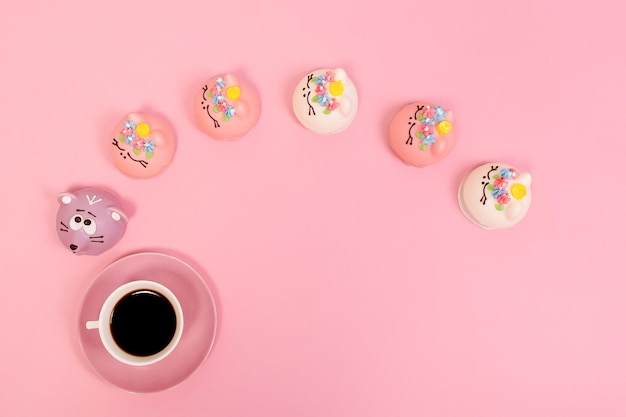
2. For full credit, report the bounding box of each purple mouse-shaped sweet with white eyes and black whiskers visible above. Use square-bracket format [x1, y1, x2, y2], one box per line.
[57, 188, 127, 255]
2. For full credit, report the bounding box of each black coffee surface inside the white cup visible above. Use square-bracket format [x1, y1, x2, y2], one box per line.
[111, 290, 176, 356]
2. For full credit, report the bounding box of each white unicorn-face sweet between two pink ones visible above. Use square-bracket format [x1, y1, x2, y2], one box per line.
[293, 68, 359, 134]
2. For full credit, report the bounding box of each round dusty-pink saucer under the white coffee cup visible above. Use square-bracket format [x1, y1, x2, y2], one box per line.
[78, 252, 217, 393]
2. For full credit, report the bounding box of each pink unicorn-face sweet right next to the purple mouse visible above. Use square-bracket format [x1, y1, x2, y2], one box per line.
[109, 113, 176, 178]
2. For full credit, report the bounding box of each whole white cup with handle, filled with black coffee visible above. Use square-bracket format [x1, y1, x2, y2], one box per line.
[85, 280, 183, 366]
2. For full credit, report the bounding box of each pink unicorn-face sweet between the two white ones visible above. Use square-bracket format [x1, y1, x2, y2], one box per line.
[389, 103, 456, 167]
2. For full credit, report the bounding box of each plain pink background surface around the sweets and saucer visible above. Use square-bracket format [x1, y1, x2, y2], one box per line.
[0, 0, 626, 417]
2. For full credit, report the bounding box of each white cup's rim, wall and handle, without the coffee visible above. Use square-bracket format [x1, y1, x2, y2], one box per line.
[85, 280, 183, 366]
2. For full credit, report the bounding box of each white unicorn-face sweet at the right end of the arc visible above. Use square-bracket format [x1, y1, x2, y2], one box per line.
[459, 163, 532, 229]
